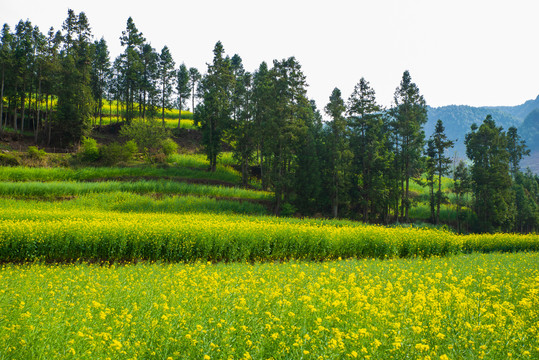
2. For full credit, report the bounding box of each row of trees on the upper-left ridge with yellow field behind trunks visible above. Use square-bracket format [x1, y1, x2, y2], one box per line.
[0, 10, 200, 146]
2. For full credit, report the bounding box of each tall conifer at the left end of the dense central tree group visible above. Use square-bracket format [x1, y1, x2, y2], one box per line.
[196, 41, 234, 171]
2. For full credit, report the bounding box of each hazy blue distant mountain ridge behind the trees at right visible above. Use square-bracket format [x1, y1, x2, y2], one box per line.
[425, 96, 539, 173]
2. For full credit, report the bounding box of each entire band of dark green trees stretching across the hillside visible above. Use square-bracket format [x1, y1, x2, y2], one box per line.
[0, 10, 539, 233]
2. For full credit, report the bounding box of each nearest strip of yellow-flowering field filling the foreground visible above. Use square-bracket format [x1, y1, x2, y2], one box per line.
[0, 253, 539, 360]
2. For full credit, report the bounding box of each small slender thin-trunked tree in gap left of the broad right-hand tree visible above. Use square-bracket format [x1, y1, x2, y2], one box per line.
[432, 120, 454, 225]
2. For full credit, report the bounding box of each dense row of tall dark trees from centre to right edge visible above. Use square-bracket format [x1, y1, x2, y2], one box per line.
[195, 42, 539, 231]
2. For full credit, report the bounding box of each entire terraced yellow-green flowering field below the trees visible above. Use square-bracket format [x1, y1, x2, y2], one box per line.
[0, 148, 539, 360]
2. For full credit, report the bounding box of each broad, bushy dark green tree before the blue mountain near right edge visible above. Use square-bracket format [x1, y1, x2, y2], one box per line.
[465, 115, 515, 232]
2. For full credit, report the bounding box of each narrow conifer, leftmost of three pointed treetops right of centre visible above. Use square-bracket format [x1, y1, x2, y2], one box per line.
[325, 88, 352, 218]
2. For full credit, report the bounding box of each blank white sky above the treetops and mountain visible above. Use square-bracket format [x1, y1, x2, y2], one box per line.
[0, 0, 539, 109]
